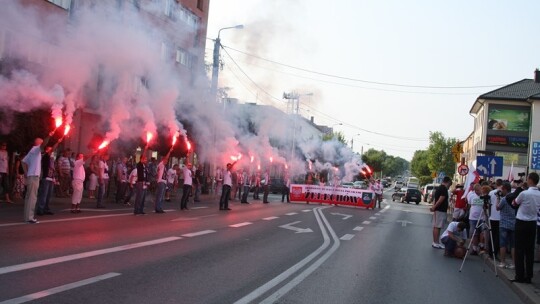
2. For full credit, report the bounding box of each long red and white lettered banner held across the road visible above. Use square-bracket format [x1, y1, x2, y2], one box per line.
[290, 184, 375, 208]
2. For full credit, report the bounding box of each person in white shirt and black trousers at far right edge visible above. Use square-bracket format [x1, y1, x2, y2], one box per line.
[511, 172, 540, 284]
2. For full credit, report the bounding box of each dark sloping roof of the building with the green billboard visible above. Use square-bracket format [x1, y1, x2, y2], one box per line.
[469, 79, 540, 113]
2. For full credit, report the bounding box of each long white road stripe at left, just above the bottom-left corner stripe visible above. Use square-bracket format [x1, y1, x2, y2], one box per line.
[0, 236, 182, 275]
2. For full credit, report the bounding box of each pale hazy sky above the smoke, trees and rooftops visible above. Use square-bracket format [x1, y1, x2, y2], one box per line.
[206, 0, 540, 160]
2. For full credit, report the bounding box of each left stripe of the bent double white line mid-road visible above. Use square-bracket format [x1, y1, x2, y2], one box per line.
[234, 207, 330, 304]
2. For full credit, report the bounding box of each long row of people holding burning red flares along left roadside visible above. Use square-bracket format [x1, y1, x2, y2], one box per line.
[0, 134, 296, 224]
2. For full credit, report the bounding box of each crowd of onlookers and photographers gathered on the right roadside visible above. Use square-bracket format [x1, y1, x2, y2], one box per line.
[431, 172, 540, 284]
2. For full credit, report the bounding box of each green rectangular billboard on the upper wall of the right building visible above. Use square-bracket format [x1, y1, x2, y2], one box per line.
[487, 105, 531, 132]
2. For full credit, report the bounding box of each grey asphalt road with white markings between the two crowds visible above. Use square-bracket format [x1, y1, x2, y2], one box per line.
[0, 189, 521, 304]
